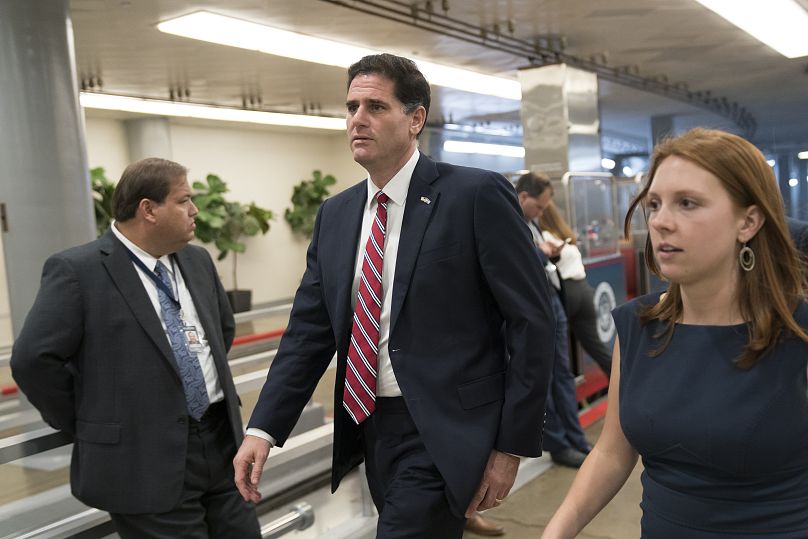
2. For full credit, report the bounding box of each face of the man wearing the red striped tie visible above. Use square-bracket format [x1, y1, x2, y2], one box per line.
[346, 74, 426, 181]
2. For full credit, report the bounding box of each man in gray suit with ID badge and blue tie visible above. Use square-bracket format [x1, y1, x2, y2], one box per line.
[11, 159, 259, 538]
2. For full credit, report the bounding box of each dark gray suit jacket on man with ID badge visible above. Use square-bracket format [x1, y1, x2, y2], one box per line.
[11, 231, 237, 513]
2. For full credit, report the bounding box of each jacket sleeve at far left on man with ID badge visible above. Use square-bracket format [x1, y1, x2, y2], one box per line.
[11, 255, 84, 434]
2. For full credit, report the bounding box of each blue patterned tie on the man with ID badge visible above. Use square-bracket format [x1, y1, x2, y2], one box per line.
[154, 260, 210, 420]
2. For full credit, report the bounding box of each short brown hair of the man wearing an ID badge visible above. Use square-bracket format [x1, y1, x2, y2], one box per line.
[112, 157, 188, 222]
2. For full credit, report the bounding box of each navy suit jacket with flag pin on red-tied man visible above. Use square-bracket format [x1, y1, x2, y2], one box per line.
[248, 155, 555, 513]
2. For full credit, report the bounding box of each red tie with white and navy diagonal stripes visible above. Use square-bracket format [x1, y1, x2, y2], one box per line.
[342, 191, 389, 425]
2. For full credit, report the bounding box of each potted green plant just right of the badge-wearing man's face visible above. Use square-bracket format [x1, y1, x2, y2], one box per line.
[191, 174, 274, 312]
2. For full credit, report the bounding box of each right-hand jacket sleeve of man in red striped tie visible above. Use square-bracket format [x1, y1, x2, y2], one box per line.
[474, 175, 556, 456]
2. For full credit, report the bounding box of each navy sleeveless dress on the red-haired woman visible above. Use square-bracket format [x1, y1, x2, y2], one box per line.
[613, 294, 808, 539]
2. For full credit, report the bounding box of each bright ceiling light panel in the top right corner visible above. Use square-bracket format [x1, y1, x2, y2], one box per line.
[696, 0, 808, 58]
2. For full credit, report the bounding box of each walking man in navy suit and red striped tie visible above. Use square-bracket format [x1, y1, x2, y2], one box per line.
[234, 54, 554, 539]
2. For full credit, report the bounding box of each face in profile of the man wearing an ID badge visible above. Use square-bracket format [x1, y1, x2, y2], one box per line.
[153, 176, 199, 254]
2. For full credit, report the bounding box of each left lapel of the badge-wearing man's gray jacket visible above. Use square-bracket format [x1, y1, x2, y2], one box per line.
[100, 230, 179, 376]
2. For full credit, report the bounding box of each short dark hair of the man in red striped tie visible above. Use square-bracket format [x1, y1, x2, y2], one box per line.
[348, 53, 431, 120]
